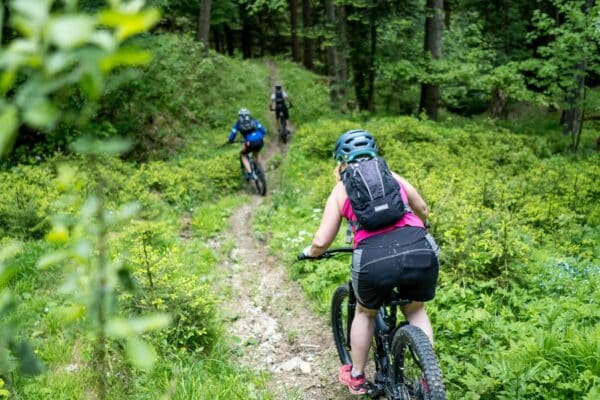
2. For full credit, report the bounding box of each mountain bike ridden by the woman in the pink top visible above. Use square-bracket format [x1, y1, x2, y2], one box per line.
[298, 247, 446, 400]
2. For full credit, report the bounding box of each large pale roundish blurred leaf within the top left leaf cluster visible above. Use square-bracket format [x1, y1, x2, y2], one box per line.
[48, 14, 95, 49]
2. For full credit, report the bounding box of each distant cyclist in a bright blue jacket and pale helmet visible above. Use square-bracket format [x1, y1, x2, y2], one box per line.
[227, 108, 267, 180]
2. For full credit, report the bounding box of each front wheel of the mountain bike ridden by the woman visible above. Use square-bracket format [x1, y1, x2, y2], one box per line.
[331, 284, 354, 364]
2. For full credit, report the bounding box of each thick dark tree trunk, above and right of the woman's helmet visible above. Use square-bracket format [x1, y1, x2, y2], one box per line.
[419, 0, 444, 120]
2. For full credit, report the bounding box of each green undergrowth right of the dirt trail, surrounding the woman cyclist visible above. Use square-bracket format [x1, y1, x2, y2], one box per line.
[257, 117, 600, 399]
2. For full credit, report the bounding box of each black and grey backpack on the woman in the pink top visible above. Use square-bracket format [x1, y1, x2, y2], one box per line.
[342, 158, 410, 231]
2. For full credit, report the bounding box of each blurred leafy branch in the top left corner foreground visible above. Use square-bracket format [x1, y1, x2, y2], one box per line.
[0, 0, 159, 156]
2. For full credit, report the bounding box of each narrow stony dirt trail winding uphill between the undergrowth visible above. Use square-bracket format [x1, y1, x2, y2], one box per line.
[218, 64, 349, 400]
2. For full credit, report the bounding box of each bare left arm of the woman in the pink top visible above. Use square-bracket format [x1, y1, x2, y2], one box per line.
[308, 183, 344, 257]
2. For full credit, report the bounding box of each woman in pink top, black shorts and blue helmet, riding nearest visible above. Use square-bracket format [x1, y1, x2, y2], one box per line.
[303, 130, 438, 394]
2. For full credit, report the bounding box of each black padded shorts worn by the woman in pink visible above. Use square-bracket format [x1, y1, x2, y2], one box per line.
[352, 226, 439, 310]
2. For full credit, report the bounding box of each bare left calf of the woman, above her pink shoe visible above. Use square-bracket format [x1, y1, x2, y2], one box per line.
[350, 304, 377, 374]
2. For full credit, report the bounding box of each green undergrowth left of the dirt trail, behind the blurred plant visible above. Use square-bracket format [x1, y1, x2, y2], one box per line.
[0, 35, 269, 399]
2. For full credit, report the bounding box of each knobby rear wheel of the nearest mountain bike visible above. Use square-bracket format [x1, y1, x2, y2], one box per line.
[392, 325, 446, 400]
